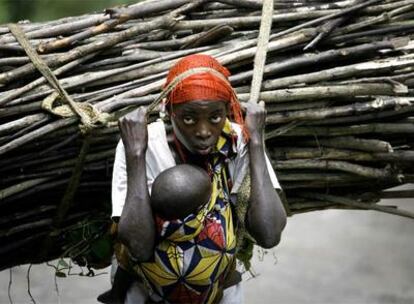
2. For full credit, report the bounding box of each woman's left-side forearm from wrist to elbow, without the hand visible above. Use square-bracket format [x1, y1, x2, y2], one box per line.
[118, 152, 155, 262]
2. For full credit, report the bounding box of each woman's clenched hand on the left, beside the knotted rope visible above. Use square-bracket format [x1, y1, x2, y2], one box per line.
[118, 107, 148, 155]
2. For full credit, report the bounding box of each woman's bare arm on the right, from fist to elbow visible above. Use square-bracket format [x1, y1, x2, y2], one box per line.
[246, 102, 286, 248]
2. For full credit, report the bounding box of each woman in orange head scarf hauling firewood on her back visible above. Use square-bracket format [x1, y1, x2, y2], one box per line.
[112, 54, 286, 303]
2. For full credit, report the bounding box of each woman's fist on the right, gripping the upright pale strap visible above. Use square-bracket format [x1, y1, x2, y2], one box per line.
[242, 101, 266, 142]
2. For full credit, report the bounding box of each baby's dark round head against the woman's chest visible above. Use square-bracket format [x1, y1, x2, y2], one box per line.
[151, 164, 212, 220]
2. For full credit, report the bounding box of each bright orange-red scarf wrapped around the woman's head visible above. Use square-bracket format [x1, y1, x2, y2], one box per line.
[164, 54, 247, 139]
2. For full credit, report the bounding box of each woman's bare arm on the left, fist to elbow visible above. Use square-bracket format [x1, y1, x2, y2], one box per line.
[118, 107, 155, 262]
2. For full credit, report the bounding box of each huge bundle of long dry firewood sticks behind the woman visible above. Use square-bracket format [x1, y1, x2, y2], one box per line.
[0, 0, 414, 269]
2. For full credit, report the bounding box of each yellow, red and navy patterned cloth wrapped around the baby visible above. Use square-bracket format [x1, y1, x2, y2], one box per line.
[124, 121, 236, 303]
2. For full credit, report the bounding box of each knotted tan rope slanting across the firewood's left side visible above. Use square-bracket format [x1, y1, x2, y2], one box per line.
[8, 24, 111, 131]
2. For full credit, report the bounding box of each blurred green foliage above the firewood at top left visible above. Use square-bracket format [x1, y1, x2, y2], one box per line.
[0, 0, 139, 24]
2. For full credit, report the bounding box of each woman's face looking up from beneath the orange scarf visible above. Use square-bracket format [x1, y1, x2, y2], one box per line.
[170, 100, 228, 155]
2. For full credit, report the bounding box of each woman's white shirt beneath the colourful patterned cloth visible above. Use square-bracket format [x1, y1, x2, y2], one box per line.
[112, 120, 280, 304]
